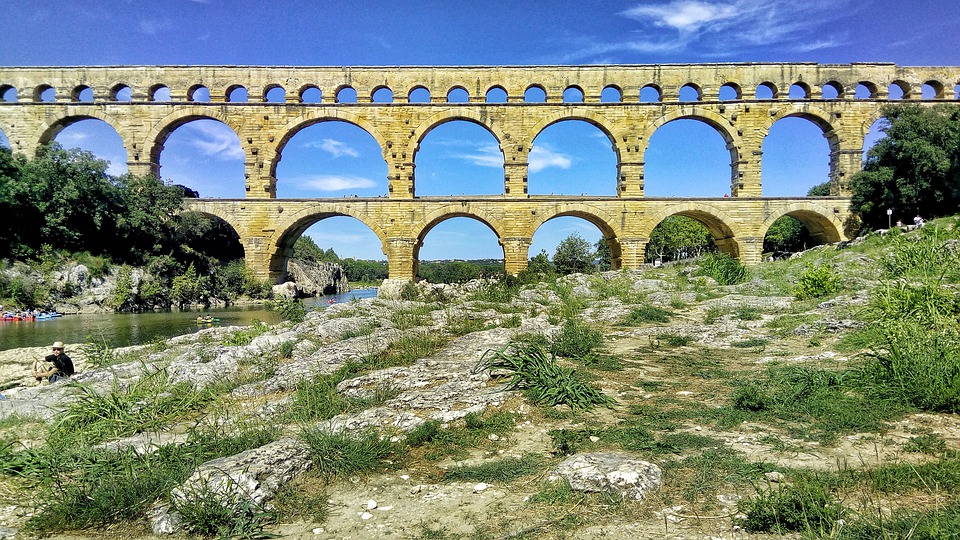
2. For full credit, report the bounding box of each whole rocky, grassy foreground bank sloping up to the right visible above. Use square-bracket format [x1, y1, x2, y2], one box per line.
[0, 223, 960, 540]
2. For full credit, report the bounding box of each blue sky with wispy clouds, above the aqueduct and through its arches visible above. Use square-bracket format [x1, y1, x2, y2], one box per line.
[0, 0, 960, 260]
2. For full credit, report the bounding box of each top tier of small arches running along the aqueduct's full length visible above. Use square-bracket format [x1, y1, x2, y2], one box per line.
[0, 63, 960, 103]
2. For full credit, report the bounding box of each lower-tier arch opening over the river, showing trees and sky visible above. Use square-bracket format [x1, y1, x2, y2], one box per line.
[276, 213, 388, 288]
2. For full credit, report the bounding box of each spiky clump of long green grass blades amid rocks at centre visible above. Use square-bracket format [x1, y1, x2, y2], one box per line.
[475, 343, 614, 411]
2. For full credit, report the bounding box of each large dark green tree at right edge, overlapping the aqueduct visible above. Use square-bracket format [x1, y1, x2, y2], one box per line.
[851, 104, 960, 227]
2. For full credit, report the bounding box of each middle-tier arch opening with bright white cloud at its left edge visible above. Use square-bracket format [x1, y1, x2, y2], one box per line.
[527, 120, 617, 196]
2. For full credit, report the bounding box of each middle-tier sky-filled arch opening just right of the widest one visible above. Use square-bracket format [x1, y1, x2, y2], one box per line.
[414, 119, 504, 196]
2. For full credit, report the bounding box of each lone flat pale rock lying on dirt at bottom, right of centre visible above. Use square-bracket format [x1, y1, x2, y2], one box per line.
[549, 452, 663, 501]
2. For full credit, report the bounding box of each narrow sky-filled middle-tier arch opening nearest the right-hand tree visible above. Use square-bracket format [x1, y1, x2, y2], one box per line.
[761, 116, 830, 197]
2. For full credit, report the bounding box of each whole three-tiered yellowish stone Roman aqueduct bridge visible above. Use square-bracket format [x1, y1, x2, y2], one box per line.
[0, 63, 960, 279]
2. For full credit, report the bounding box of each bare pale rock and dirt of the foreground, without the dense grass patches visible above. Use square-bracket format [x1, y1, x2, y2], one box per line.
[0, 238, 960, 540]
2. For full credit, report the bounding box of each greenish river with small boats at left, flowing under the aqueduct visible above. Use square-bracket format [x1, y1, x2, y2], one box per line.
[0, 289, 377, 351]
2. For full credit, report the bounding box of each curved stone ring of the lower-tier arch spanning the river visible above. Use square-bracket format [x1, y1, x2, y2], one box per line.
[267, 203, 389, 277]
